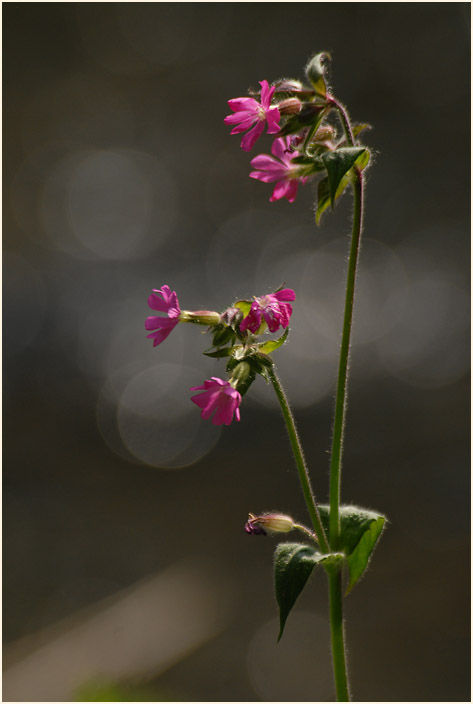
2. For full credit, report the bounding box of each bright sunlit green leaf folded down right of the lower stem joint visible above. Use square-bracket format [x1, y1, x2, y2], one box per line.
[319, 506, 386, 594]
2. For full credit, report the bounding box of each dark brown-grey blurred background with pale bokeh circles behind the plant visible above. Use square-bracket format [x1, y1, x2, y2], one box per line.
[3, 2, 470, 701]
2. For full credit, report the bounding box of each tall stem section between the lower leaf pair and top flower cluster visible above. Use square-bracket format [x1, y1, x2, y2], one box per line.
[329, 171, 363, 550]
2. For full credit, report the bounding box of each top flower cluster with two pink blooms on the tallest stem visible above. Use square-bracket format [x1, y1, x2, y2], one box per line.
[224, 53, 368, 209]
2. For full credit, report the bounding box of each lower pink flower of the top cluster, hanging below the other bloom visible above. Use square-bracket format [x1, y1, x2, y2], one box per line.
[250, 137, 307, 203]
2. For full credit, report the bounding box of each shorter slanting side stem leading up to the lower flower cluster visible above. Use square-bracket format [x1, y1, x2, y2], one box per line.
[268, 367, 329, 552]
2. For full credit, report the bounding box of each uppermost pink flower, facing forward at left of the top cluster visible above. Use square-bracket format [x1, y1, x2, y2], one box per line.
[224, 81, 280, 152]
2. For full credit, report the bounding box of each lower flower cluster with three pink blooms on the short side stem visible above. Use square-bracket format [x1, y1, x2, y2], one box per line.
[145, 285, 296, 425]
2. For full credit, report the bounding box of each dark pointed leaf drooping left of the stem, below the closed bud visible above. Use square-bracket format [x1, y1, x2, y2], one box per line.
[274, 543, 343, 641]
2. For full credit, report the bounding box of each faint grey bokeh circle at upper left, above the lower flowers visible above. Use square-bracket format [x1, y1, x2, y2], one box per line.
[39, 149, 177, 260]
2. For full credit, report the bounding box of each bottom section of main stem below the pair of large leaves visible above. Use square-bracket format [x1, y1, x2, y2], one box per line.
[329, 568, 350, 702]
